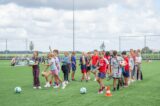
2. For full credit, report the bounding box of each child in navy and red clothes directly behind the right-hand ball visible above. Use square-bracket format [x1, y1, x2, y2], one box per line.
[80, 52, 88, 82]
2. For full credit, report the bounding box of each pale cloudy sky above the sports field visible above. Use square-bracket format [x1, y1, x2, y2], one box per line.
[0, 0, 160, 51]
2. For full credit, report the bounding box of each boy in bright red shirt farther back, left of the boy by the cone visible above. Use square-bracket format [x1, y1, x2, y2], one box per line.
[91, 50, 99, 81]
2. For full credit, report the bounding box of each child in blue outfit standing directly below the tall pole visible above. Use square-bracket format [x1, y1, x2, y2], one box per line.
[71, 52, 76, 81]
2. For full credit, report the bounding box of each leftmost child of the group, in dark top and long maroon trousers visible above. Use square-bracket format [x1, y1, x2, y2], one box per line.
[32, 51, 41, 89]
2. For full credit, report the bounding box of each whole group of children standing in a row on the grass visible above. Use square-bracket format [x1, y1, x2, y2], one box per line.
[28, 49, 142, 94]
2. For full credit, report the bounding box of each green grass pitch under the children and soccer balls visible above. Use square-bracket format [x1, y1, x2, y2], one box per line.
[0, 61, 160, 106]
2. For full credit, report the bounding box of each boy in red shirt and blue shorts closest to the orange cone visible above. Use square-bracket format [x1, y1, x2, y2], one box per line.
[97, 52, 109, 94]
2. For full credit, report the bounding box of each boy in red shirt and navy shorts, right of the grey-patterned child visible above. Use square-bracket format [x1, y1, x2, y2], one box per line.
[122, 51, 130, 87]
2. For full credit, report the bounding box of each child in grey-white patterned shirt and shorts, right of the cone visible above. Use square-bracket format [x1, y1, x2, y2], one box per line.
[111, 51, 124, 91]
